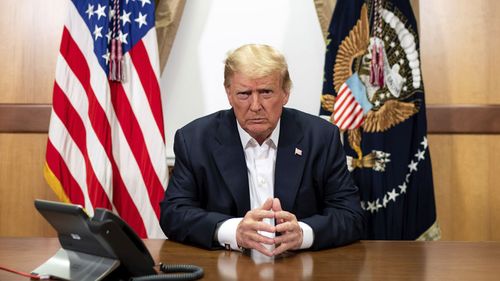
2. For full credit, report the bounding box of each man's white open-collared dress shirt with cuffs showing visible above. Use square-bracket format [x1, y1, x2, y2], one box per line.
[217, 121, 314, 250]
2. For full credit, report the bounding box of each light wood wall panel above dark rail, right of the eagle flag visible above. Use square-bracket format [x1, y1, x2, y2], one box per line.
[420, 0, 500, 104]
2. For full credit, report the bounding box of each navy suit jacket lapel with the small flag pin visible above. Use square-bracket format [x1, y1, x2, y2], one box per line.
[274, 108, 307, 211]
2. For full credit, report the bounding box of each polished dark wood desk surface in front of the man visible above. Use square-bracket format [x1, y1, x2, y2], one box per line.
[0, 238, 500, 281]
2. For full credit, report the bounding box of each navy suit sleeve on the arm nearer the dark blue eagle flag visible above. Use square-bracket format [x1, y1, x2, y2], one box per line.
[301, 127, 365, 250]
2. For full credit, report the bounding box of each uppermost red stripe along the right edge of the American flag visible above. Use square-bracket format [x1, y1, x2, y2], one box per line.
[129, 40, 165, 142]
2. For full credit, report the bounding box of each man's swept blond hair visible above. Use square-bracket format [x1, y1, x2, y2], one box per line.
[224, 44, 292, 93]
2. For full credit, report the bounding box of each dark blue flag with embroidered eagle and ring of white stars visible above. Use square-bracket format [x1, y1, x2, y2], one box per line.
[320, 0, 440, 240]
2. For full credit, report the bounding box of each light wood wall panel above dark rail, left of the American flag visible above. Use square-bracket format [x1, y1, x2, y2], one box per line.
[0, 0, 67, 103]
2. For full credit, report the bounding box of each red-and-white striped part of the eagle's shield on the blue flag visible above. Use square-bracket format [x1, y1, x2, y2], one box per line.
[333, 83, 364, 131]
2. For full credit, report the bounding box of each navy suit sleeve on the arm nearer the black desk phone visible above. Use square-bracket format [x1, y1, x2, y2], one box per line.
[160, 130, 231, 249]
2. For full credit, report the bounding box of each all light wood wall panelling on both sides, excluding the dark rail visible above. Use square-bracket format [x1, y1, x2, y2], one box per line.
[0, 0, 500, 240]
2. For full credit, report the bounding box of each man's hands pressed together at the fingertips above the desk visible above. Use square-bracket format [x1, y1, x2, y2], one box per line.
[236, 198, 303, 257]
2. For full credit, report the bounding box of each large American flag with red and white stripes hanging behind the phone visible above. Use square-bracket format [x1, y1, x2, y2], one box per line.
[44, 0, 168, 238]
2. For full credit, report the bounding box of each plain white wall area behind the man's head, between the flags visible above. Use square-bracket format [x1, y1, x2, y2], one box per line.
[160, 0, 325, 162]
